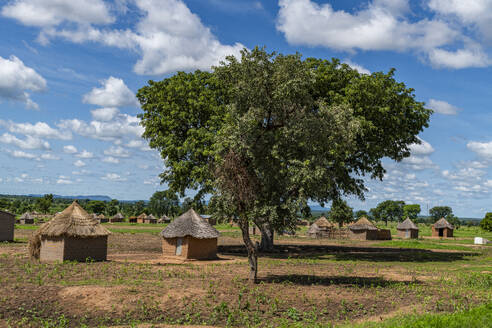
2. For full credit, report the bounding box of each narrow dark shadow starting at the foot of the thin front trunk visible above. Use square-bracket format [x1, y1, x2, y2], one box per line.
[259, 274, 420, 287]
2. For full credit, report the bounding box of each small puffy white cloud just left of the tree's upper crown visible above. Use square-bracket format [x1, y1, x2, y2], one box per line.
[83, 76, 138, 107]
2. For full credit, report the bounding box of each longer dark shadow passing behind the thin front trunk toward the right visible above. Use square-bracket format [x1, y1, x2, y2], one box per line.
[218, 245, 479, 262]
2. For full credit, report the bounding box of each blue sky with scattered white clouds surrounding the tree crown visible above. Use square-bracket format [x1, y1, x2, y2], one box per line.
[0, 0, 492, 217]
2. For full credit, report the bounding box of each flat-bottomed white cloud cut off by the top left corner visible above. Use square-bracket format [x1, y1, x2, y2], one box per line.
[2, 0, 114, 27]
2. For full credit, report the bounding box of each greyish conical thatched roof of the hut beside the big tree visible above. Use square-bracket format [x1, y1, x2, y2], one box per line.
[161, 209, 220, 239]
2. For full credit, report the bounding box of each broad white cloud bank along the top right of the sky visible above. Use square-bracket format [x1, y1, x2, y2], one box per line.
[277, 0, 492, 69]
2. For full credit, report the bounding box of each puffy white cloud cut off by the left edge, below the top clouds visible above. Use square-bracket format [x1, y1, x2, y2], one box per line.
[0, 56, 46, 109]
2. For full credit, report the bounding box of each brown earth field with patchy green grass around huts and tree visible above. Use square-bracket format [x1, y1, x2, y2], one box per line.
[0, 224, 492, 328]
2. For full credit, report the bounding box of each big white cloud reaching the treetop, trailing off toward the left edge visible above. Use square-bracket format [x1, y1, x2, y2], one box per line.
[3, 0, 244, 75]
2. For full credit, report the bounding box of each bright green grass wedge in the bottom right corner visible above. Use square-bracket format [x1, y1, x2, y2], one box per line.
[343, 303, 492, 328]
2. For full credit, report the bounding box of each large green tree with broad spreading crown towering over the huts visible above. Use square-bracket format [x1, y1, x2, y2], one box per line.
[137, 48, 431, 279]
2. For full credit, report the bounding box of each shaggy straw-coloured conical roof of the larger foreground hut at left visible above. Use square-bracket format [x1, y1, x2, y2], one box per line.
[37, 201, 110, 238]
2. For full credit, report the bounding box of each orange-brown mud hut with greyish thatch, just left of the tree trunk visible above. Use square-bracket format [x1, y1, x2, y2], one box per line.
[161, 209, 219, 260]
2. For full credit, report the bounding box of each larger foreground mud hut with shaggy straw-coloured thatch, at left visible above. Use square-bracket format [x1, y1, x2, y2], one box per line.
[29, 201, 110, 262]
